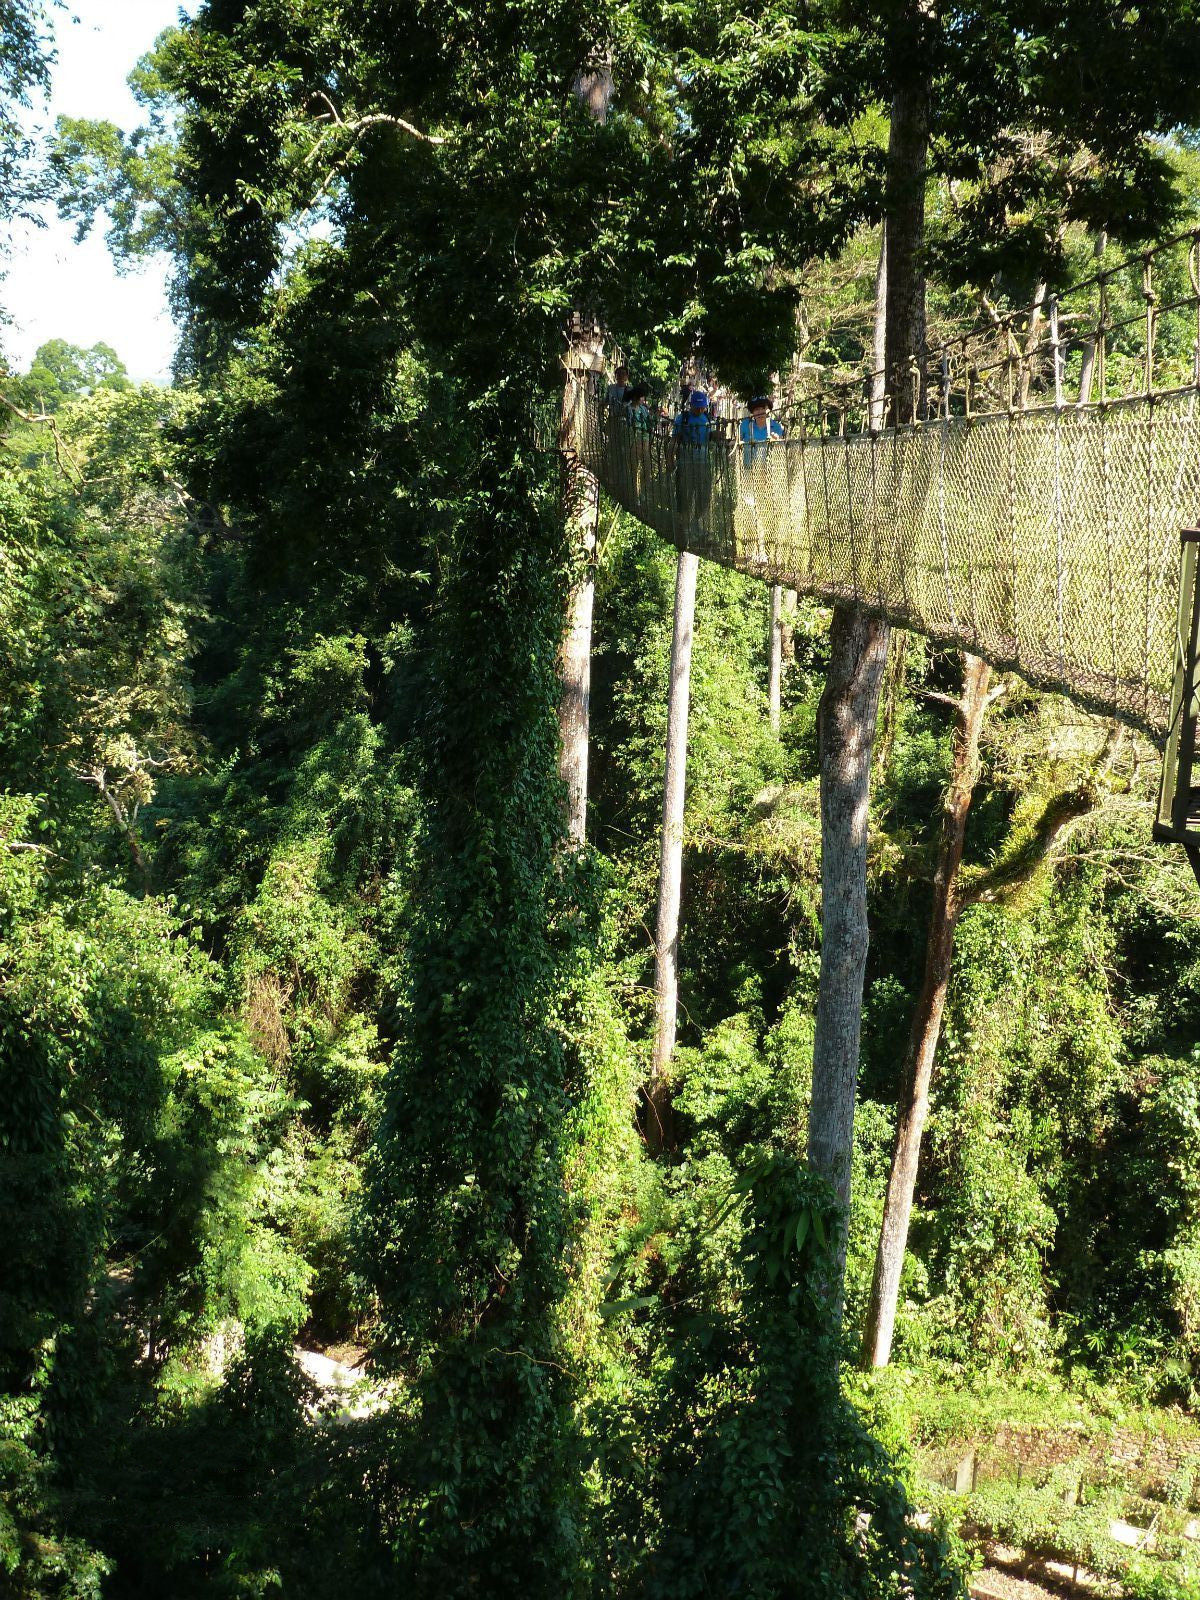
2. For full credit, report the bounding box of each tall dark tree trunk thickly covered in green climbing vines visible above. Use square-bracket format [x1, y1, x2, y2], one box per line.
[366, 377, 579, 1600]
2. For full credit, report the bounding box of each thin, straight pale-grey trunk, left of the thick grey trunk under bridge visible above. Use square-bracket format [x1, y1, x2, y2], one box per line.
[650, 550, 699, 1146]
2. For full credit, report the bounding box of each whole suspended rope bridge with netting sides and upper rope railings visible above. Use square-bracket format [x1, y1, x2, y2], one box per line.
[563, 234, 1200, 741]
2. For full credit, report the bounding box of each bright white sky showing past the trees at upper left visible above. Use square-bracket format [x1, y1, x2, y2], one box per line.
[0, 0, 195, 382]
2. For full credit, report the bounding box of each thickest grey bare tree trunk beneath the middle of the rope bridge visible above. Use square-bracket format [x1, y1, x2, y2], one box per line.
[808, 605, 890, 1286]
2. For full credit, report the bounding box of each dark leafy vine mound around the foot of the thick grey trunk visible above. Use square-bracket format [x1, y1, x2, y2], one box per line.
[608, 1154, 963, 1597]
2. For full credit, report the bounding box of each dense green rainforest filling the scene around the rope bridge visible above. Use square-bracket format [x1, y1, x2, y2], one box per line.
[0, 0, 1200, 1600]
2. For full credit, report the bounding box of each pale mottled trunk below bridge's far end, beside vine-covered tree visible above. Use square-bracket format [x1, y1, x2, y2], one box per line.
[558, 462, 600, 845]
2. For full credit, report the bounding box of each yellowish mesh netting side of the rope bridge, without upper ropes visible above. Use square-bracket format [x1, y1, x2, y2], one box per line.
[566, 374, 1200, 739]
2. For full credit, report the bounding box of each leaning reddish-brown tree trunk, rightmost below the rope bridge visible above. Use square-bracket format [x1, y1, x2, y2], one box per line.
[862, 656, 990, 1366]
